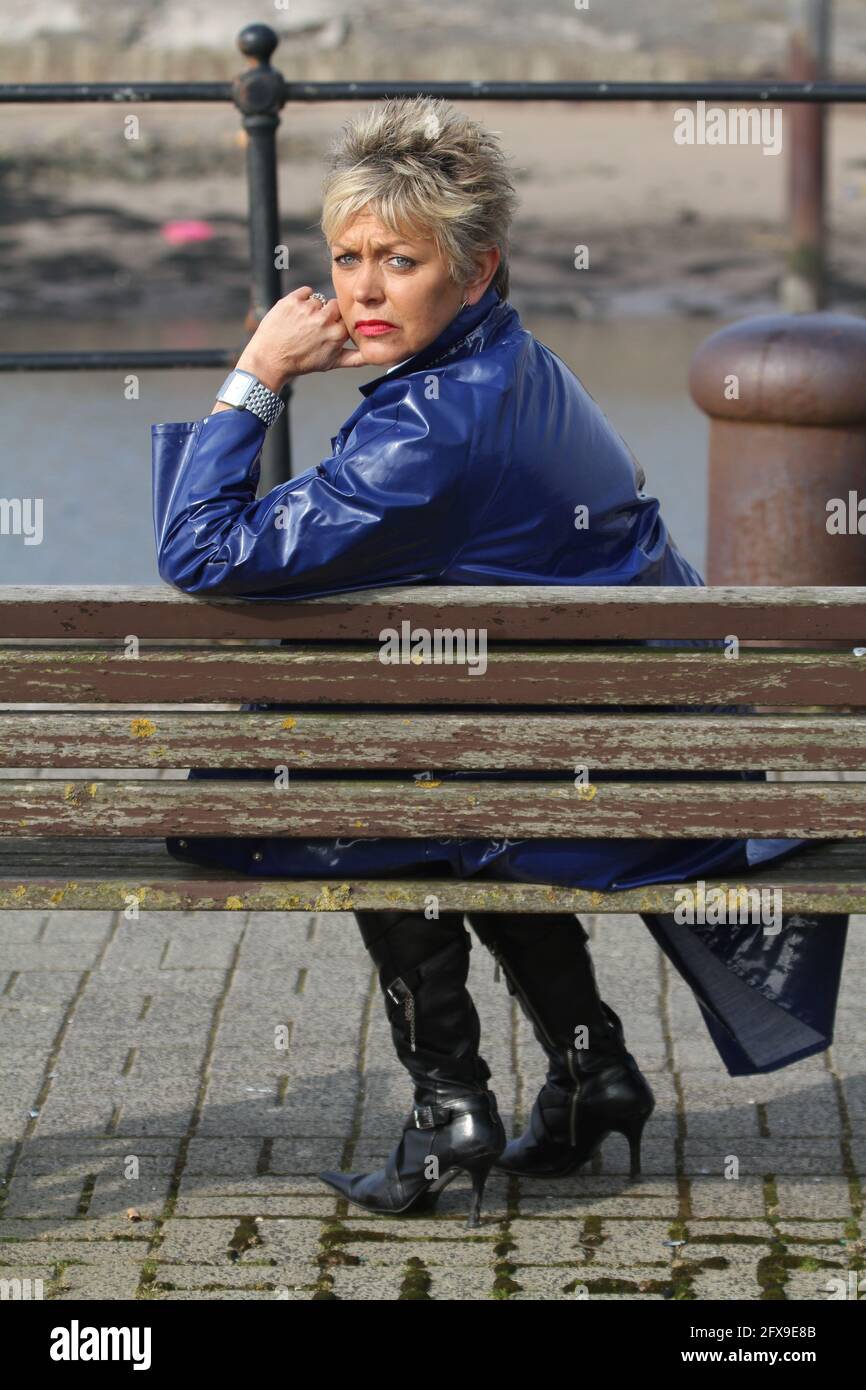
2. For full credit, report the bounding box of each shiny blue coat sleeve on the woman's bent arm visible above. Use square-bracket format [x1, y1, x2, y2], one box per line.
[152, 379, 473, 598]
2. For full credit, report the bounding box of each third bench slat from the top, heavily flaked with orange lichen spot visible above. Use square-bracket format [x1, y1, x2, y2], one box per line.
[0, 708, 866, 773]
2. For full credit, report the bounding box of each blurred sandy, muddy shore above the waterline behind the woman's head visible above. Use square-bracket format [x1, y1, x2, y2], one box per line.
[0, 0, 866, 318]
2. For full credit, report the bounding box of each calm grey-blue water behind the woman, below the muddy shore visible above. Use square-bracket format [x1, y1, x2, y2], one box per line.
[0, 316, 720, 584]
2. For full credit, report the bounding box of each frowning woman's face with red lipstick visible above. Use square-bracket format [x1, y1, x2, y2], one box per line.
[329, 213, 499, 367]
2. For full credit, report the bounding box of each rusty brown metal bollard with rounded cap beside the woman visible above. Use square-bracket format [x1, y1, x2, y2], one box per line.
[689, 313, 866, 585]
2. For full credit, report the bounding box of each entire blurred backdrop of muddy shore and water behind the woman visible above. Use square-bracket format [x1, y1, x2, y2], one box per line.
[0, 0, 866, 584]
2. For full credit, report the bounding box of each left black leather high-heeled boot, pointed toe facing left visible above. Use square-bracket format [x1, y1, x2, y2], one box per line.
[318, 912, 506, 1227]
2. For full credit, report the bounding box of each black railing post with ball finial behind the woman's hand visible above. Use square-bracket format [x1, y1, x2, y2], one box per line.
[232, 24, 292, 496]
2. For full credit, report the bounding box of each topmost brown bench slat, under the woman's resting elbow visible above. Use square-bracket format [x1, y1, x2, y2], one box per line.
[0, 584, 866, 644]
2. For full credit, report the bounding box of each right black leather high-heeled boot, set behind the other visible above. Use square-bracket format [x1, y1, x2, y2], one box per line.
[468, 912, 655, 1177]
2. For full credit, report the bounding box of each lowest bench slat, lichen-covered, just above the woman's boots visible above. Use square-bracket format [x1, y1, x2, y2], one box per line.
[0, 840, 866, 911]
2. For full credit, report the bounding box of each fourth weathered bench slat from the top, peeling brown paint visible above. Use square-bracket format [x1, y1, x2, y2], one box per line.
[0, 777, 866, 840]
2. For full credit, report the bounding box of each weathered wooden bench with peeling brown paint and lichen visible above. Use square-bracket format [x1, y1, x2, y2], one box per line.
[0, 585, 866, 913]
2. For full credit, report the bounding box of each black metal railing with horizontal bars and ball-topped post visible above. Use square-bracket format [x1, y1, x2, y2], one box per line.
[0, 24, 866, 493]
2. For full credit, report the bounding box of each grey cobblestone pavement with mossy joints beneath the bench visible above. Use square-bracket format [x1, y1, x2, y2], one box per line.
[0, 912, 866, 1301]
